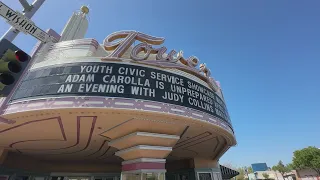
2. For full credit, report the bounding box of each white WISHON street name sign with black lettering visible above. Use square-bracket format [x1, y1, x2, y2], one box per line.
[0, 1, 53, 42]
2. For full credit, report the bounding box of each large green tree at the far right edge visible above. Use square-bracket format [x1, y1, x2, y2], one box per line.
[292, 146, 320, 175]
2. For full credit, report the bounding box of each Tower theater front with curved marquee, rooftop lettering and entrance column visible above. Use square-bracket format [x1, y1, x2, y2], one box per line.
[0, 31, 236, 180]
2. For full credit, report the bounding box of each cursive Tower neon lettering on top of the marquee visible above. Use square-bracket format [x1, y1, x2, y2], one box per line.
[103, 31, 218, 90]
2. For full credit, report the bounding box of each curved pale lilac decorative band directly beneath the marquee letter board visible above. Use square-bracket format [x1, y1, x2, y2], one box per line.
[5, 96, 234, 135]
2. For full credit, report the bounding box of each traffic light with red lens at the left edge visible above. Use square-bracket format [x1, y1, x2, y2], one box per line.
[0, 39, 31, 97]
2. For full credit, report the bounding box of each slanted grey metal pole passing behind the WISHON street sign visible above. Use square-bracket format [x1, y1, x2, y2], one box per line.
[1, 0, 45, 42]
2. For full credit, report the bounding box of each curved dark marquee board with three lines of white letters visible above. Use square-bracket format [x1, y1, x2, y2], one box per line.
[11, 62, 230, 123]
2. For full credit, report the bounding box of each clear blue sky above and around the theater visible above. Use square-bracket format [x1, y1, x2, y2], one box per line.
[0, 0, 320, 169]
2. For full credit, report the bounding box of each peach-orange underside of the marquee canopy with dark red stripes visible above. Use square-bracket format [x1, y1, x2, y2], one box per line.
[0, 108, 233, 163]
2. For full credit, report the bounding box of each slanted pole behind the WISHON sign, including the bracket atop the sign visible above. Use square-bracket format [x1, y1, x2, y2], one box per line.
[1, 0, 45, 42]
